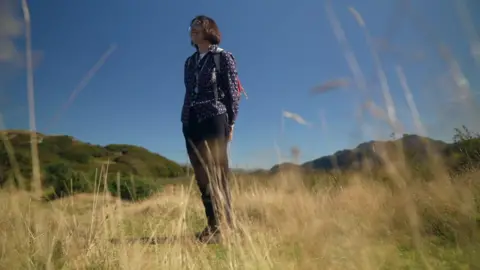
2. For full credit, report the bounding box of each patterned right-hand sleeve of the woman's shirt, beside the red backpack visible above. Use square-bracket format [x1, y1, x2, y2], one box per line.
[220, 52, 240, 126]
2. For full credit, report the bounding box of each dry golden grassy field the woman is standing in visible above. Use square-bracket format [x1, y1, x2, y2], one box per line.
[0, 165, 480, 269]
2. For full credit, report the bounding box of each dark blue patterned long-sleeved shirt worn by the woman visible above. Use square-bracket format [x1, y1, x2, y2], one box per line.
[182, 45, 240, 125]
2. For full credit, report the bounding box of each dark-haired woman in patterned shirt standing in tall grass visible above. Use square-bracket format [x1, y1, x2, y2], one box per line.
[182, 16, 240, 242]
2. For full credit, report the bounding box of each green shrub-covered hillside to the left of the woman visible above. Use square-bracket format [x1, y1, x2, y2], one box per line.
[0, 130, 185, 199]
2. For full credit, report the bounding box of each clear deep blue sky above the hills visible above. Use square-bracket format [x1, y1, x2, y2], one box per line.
[0, 0, 480, 167]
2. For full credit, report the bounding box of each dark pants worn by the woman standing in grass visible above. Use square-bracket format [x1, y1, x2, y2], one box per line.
[183, 114, 232, 230]
